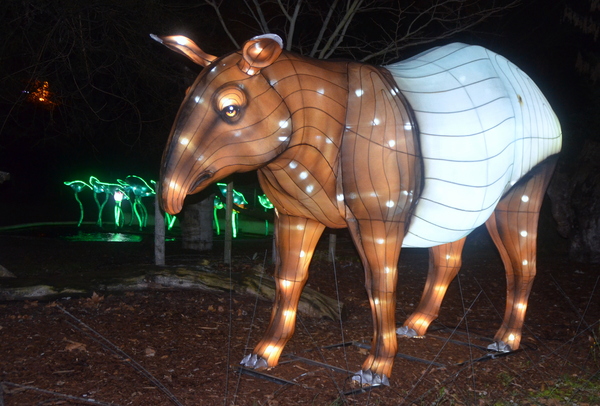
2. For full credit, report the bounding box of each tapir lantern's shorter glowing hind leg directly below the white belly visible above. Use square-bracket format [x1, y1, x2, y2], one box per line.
[396, 237, 467, 337]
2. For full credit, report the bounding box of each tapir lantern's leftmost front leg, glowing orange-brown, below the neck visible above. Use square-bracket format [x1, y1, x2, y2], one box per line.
[241, 214, 325, 369]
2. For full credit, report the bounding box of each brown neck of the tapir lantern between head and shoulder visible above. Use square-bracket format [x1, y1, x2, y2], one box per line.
[259, 53, 348, 227]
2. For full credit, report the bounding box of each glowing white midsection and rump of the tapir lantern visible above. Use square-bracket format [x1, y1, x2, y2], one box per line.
[386, 43, 561, 247]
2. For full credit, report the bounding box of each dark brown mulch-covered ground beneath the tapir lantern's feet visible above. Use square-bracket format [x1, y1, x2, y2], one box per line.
[0, 227, 600, 406]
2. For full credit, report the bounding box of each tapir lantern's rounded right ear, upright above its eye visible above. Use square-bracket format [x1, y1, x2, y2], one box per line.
[238, 34, 283, 75]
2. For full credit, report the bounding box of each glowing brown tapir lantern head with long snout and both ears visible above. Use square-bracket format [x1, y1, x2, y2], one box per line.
[156, 35, 290, 214]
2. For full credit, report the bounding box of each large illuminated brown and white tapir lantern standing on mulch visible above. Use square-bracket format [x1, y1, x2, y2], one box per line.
[153, 35, 561, 385]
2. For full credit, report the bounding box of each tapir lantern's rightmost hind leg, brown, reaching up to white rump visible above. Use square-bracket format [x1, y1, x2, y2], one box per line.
[486, 159, 555, 351]
